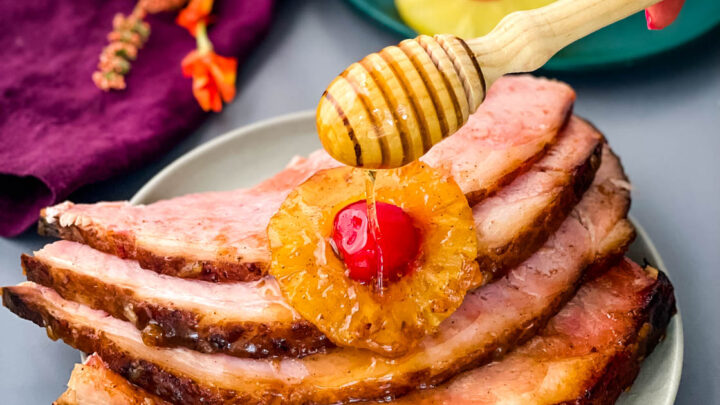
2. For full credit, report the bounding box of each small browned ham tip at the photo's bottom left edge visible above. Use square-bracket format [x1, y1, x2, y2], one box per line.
[53, 354, 170, 405]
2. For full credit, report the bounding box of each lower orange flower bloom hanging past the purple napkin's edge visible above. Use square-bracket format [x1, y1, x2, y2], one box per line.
[182, 50, 237, 112]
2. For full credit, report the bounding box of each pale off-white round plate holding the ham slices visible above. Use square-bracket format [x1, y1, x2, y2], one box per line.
[131, 111, 683, 405]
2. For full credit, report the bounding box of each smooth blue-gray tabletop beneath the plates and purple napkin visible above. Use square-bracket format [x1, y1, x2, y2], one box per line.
[0, 0, 720, 404]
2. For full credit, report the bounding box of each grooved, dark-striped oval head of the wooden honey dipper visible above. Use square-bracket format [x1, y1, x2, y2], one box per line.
[317, 35, 485, 169]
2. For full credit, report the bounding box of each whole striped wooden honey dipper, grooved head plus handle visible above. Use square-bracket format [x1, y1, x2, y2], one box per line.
[317, 0, 659, 169]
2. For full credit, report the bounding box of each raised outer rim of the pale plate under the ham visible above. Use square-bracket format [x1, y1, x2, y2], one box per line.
[131, 110, 685, 405]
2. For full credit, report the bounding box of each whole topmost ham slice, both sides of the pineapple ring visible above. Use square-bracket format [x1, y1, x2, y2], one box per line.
[39, 76, 575, 281]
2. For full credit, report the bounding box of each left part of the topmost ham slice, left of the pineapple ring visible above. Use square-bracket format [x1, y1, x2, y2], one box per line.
[39, 151, 338, 281]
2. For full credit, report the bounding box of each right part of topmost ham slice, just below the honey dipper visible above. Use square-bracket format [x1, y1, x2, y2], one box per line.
[421, 75, 575, 205]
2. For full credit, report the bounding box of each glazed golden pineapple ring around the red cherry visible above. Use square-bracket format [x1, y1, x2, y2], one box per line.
[267, 162, 478, 357]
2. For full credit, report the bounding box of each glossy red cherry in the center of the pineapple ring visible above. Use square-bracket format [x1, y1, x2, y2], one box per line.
[332, 200, 420, 283]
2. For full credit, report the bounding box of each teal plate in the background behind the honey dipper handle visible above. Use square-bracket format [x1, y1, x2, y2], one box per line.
[346, 0, 720, 71]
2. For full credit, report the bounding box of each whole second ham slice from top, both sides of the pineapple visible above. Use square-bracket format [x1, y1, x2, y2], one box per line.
[22, 117, 602, 358]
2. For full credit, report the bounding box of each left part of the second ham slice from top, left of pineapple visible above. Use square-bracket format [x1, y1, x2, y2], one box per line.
[22, 241, 331, 357]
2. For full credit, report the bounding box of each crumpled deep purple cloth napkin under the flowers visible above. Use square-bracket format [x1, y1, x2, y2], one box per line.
[0, 0, 273, 236]
